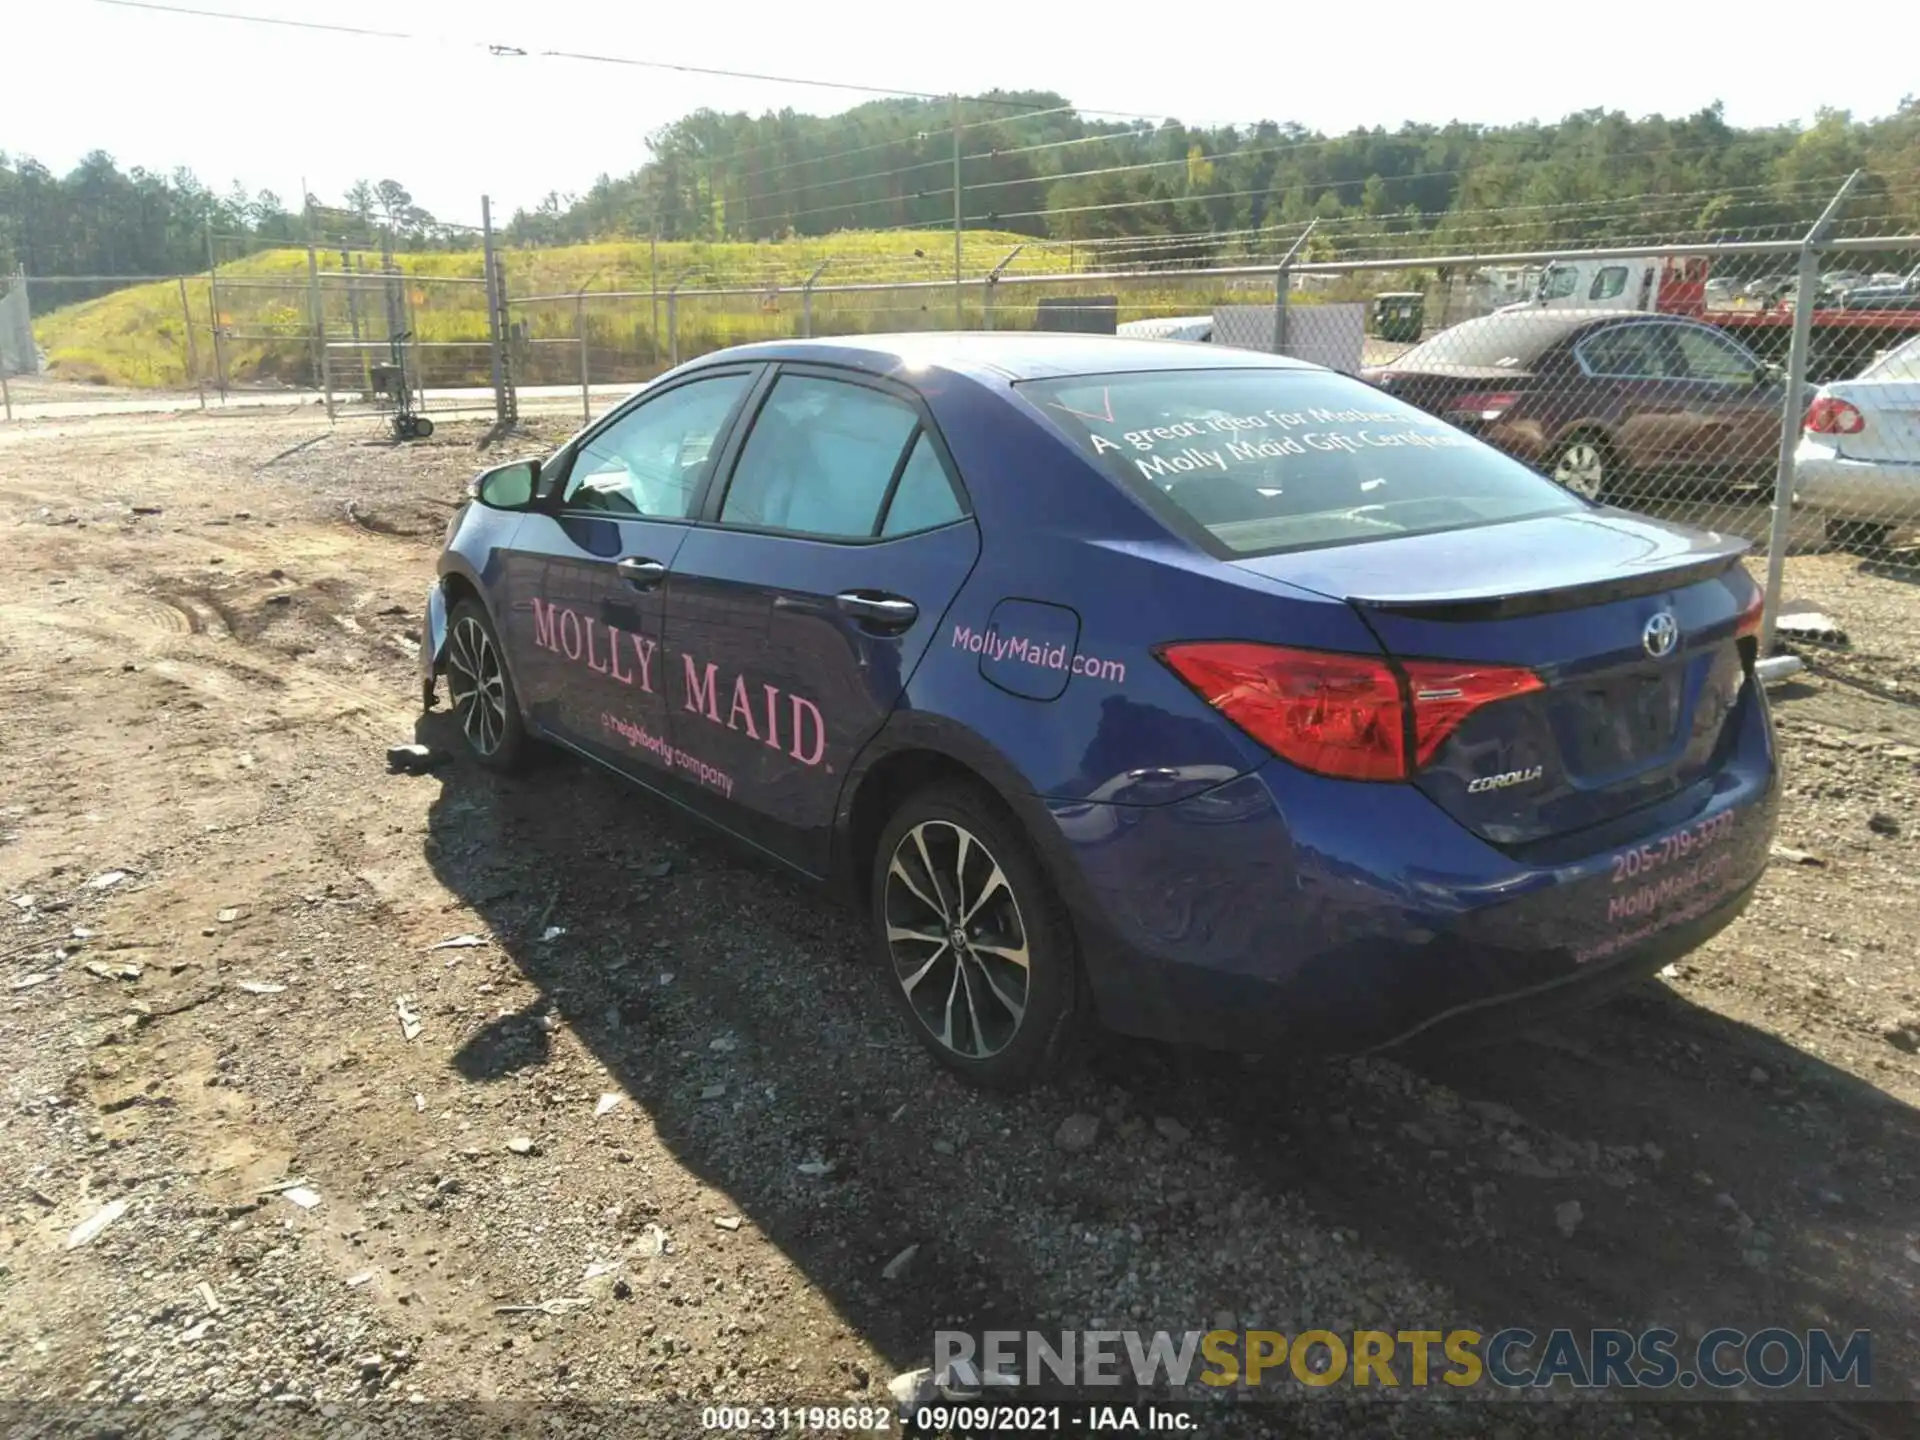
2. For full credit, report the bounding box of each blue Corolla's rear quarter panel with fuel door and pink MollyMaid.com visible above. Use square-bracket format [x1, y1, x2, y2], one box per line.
[904, 380, 1377, 804]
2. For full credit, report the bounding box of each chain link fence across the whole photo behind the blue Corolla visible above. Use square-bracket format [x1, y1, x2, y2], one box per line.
[0, 182, 1920, 648]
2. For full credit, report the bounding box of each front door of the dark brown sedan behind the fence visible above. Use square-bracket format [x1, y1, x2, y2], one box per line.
[1661, 323, 1786, 482]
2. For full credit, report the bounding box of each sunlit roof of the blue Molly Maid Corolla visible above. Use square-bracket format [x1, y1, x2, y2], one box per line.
[679, 330, 1321, 380]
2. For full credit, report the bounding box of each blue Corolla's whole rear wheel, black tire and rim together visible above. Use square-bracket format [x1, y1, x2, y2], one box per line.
[868, 783, 1081, 1091]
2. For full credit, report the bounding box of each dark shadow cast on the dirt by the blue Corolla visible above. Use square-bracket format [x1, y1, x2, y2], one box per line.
[419, 714, 1920, 1432]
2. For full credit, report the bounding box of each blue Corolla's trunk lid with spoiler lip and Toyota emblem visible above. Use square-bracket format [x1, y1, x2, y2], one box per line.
[1236, 509, 1755, 845]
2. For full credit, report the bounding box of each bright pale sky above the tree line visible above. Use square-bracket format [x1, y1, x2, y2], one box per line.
[15, 0, 1920, 223]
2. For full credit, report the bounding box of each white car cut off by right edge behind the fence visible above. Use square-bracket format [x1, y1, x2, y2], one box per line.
[1793, 336, 1920, 549]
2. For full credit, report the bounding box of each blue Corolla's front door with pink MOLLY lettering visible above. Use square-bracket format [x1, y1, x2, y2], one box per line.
[507, 367, 760, 780]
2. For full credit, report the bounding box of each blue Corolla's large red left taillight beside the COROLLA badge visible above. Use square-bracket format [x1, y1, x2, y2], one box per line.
[1160, 641, 1542, 780]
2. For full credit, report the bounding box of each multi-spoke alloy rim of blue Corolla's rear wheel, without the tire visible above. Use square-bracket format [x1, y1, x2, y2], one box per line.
[885, 820, 1031, 1060]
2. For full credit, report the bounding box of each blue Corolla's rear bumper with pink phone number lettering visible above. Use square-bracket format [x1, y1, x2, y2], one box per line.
[1050, 683, 1778, 1052]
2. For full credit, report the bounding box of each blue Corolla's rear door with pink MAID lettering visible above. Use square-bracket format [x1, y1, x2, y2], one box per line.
[666, 365, 979, 874]
